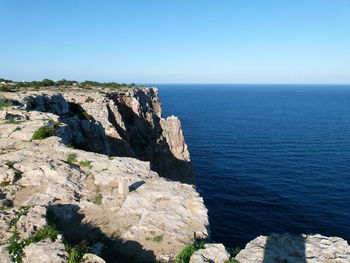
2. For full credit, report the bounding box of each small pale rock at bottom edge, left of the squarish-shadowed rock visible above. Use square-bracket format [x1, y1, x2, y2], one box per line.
[190, 244, 230, 263]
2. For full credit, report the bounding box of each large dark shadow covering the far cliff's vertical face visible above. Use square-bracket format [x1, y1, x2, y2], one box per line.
[26, 92, 194, 184]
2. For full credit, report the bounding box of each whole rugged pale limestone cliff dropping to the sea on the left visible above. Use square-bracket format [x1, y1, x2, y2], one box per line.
[0, 85, 208, 262]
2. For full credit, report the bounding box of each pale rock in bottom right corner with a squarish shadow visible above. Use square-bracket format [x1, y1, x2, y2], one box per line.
[235, 234, 350, 263]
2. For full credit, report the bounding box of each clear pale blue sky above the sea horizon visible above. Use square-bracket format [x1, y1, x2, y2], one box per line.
[0, 0, 350, 83]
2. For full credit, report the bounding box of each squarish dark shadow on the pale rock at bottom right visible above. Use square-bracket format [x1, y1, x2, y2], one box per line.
[263, 234, 306, 263]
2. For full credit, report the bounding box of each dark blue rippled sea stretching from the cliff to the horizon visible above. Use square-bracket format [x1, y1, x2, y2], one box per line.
[156, 85, 350, 250]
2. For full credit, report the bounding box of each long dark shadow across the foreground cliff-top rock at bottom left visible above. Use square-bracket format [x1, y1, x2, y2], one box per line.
[49, 204, 156, 263]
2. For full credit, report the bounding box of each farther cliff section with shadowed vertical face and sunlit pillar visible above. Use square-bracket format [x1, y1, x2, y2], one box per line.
[15, 88, 194, 184]
